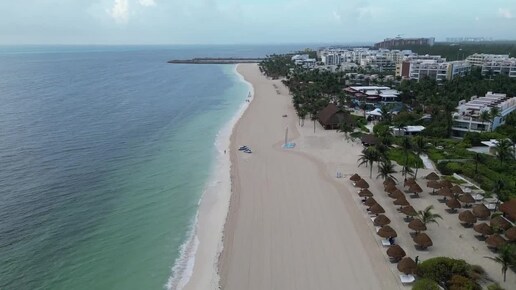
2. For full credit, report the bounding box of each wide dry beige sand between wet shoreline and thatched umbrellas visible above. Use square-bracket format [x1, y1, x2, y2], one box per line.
[219, 64, 401, 290]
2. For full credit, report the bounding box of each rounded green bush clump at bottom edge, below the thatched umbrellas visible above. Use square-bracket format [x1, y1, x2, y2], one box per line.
[417, 257, 483, 290]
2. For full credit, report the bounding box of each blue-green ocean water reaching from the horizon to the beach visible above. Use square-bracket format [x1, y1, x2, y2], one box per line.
[0, 45, 307, 289]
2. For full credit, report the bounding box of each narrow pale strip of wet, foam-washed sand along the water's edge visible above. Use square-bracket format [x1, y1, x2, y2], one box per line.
[171, 64, 254, 289]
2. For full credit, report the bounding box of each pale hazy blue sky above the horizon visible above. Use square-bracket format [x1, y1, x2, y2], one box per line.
[0, 0, 516, 45]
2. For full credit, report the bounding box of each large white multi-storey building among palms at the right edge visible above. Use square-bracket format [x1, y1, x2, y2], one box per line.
[452, 92, 516, 137]
